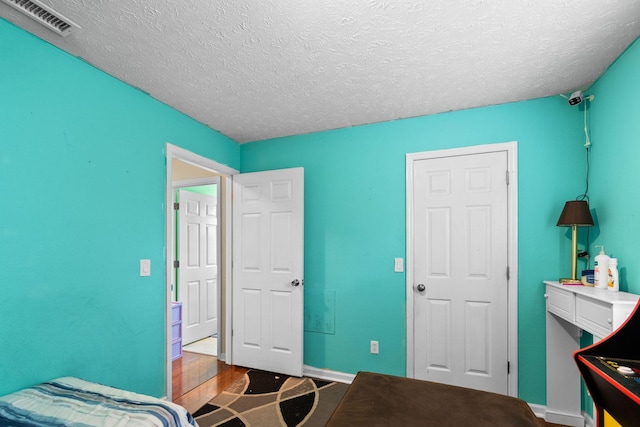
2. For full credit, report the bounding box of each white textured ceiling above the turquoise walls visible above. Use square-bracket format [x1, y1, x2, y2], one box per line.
[0, 0, 640, 142]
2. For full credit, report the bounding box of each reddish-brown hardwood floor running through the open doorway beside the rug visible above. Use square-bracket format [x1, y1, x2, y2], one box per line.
[171, 351, 247, 413]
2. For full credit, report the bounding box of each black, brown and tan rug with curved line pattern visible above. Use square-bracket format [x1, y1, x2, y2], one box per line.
[193, 370, 348, 427]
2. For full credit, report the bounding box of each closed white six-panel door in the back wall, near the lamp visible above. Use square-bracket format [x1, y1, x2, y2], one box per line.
[412, 151, 508, 394]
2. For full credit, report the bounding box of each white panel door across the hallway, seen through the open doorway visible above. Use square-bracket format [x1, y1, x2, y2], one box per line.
[177, 190, 218, 345]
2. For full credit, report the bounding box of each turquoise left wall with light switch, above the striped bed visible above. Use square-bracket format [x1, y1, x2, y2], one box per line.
[0, 19, 240, 396]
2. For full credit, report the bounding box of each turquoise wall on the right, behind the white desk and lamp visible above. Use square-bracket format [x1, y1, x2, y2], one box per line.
[589, 40, 640, 294]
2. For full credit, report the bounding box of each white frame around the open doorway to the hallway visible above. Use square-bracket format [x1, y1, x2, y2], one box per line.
[165, 143, 238, 400]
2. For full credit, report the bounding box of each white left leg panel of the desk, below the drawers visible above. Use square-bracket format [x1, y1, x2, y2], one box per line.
[544, 311, 584, 427]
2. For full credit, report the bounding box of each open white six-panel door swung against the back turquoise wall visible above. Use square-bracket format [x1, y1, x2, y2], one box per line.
[232, 168, 304, 376]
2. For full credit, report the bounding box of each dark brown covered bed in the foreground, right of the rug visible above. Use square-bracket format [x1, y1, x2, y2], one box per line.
[327, 372, 540, 427]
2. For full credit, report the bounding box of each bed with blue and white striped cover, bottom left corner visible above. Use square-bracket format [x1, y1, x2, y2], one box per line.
[0, 377, 197, 427]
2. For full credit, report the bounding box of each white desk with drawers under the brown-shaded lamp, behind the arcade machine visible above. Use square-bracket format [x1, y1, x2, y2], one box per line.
[544, 281, 640, 427]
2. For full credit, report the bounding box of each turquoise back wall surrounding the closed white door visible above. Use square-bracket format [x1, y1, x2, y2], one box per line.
[241, 97, 584, 404]
